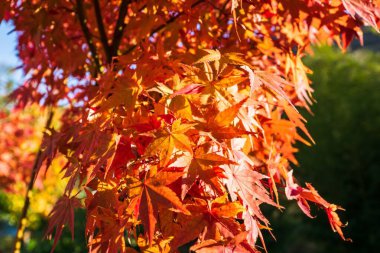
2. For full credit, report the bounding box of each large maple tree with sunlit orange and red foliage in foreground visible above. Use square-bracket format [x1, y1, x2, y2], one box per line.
[0, 0, 380, 252]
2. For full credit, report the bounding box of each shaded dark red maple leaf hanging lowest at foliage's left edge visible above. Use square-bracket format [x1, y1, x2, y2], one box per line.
[46, 194, 81, 252]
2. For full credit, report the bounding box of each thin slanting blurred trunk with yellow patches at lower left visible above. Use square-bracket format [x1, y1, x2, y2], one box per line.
[13, 109, 54, 253]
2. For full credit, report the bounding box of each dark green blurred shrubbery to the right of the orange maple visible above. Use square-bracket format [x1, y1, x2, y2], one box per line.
[268, 44, 380, 253]
